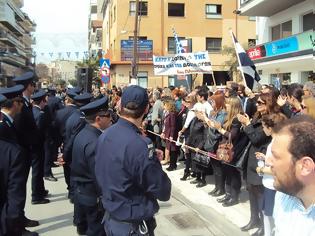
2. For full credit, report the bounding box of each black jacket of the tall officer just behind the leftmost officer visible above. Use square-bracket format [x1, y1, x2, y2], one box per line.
[15, 97, 39, 150]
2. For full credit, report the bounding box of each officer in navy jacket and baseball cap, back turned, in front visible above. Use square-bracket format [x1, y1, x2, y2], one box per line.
[95, 86, 171, 236]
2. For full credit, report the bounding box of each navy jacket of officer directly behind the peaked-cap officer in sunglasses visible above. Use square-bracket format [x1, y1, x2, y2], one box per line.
[63, 110, 86, 163]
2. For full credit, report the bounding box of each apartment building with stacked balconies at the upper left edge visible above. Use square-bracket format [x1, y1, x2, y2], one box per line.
[0, 0, 36, 85]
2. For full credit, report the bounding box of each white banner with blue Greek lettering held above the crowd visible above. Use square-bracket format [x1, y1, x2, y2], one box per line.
[153, 51, 212, 75]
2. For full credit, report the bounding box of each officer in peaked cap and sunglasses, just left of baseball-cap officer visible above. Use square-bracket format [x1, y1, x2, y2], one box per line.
[71, 97, 111, 236]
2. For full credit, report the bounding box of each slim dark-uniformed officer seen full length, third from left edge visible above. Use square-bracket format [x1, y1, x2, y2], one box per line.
[31, 89, 50, 204]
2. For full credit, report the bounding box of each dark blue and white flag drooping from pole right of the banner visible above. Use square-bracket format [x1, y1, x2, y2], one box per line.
[230, 31, 260, 90]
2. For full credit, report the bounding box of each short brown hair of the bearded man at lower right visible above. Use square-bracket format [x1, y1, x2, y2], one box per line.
[274, 115, 315, 162]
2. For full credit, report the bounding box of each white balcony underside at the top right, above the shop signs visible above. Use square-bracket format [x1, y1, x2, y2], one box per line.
[239, 0, 305, 17]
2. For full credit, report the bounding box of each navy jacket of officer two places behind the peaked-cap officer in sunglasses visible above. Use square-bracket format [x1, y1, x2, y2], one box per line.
[55, 104, 78, 144]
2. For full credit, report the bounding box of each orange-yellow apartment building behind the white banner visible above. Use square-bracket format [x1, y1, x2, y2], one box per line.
[100, 0, 256, 87]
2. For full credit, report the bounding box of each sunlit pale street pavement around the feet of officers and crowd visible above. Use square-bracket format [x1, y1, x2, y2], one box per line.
[25, 163, 255, 236]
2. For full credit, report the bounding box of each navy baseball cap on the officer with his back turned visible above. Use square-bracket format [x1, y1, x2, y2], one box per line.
[121, 85, 149, 109]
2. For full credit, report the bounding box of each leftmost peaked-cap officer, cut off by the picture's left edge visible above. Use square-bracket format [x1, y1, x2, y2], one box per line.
[0, 85, 38, 236]
